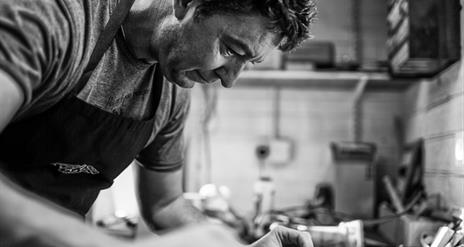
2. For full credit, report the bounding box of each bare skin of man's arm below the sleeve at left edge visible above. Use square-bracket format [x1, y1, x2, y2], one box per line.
[0, 70, 23, 132]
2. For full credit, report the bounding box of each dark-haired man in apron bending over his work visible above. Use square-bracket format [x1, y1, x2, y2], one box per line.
[0, 0, 314, 247]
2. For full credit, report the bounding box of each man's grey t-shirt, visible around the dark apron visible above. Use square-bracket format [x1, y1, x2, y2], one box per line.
[0, 0, 189, 171]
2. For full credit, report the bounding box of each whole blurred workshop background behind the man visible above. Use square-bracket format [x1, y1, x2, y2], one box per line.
[89, 0, 464, 246]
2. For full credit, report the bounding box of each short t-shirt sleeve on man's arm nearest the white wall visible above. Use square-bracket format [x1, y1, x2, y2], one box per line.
[136, 89, 190, 172]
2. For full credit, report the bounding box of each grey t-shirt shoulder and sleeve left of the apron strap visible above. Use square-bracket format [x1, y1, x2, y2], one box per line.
[0, 0, 115, 118]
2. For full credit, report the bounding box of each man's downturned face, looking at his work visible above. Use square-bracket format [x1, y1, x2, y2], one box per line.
[158, 8, 280, 88]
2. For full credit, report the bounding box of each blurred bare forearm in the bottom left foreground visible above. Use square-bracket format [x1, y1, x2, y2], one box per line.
[0, 173, 129, 247]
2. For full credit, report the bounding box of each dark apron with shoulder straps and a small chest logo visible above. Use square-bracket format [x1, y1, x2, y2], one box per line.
[0, 0, 162, 215]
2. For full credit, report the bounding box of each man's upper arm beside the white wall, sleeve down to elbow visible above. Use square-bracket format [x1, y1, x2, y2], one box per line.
[136, 87, 190, 211]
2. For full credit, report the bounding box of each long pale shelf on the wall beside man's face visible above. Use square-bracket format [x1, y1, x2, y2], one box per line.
[236, 70, 416, 90]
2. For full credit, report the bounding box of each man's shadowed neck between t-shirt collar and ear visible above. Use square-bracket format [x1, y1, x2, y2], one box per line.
[123, 0, 173, 63]
